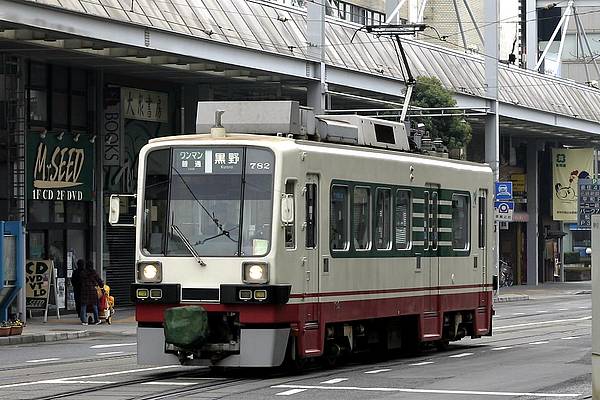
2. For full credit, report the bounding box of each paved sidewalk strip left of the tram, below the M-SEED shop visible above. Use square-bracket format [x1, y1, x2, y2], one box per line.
[0, 307, 137, 346]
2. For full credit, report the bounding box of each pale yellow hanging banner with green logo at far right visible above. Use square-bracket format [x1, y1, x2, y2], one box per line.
[552, 149, 594, 221]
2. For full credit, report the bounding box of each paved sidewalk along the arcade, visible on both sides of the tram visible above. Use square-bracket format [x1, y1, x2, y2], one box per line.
[0, 281, 592, 346]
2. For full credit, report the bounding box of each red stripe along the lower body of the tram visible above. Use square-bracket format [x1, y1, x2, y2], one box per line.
[136, 291, 492, 357]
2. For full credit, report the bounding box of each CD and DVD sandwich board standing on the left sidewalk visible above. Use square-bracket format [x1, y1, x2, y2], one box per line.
[25, 260, 54, 310]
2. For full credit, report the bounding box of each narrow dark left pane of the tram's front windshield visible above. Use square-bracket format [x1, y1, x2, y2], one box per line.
[143, 149, 171, 254]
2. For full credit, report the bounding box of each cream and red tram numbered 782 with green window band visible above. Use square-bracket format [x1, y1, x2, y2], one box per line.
[110, 101, 494, 367]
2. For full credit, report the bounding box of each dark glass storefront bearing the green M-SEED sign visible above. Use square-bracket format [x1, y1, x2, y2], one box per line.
[25, 61, 95, 310]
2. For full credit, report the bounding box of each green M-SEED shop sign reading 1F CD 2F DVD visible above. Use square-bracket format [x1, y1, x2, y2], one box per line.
[27, 133, 94, 201]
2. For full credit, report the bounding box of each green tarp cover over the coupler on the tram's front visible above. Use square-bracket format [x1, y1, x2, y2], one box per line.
[164, 306, 208, 348]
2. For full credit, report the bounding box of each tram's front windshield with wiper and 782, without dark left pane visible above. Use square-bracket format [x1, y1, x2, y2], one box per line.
[145, 147, 274, 257]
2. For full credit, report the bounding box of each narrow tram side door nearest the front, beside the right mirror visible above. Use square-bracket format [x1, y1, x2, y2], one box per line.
[302, 174, 320, 321]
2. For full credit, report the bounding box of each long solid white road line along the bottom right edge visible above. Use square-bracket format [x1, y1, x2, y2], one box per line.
[271, 385, 581, 398]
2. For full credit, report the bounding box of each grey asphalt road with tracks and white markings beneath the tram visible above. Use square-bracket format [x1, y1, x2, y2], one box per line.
[0, 294, 591, 400]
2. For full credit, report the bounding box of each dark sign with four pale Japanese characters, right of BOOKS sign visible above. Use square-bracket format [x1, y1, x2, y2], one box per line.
[121, 87, 169, 122]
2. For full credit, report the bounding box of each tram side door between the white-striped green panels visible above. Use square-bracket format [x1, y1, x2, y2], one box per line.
[423, 183, 440, 324]
